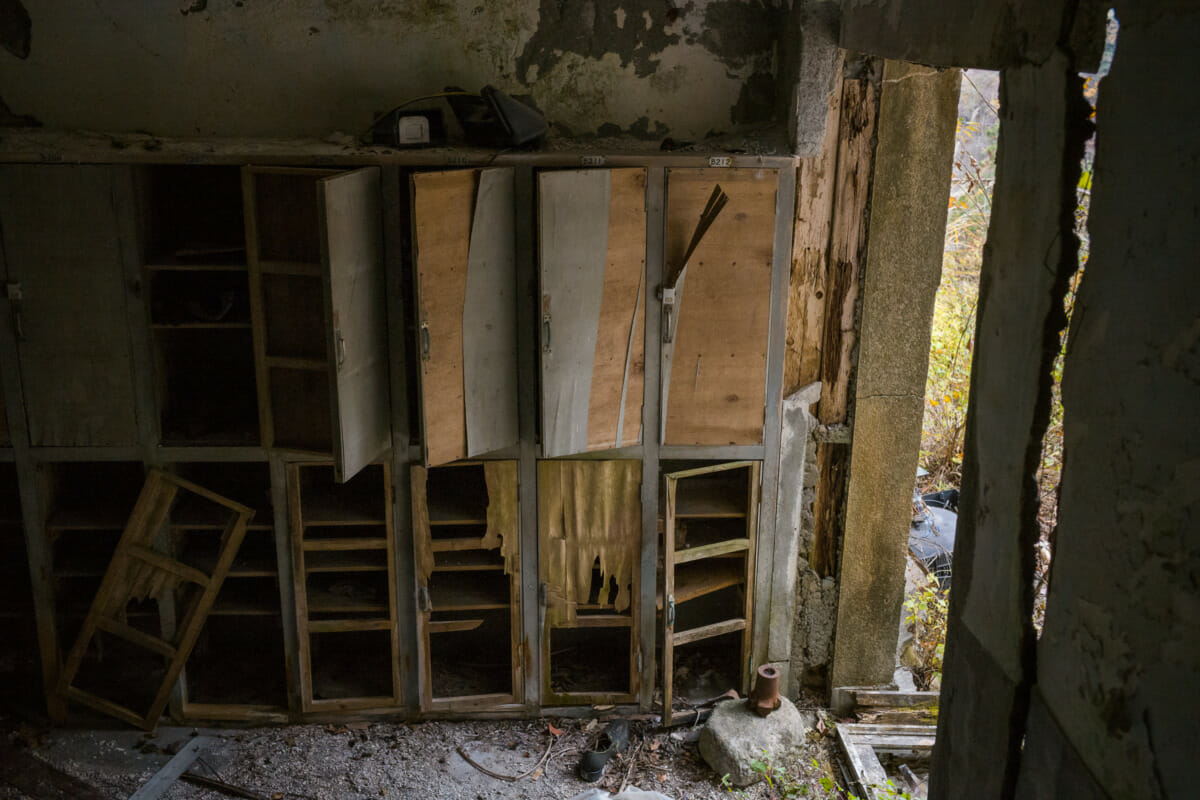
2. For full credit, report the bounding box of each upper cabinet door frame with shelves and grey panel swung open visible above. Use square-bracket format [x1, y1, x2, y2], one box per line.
[242, 167, 391, 482]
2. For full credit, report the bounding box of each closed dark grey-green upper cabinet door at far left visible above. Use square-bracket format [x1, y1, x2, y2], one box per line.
[0, 166, 140, 447]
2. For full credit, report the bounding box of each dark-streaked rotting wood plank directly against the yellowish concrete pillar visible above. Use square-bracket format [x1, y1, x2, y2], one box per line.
[810, 71, 880, 577]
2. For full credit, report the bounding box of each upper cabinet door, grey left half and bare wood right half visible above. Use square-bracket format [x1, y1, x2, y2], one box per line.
[538, 168, 647, 458]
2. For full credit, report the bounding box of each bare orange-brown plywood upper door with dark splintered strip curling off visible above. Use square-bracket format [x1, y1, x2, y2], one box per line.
[660, 169, 779, 445]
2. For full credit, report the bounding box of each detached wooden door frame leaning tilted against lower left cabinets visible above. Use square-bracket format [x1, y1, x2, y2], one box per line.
[54, 469, 254, 730]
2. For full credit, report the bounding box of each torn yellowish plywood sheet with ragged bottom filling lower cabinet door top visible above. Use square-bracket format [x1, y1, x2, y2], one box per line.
[538, 461, 642, 625]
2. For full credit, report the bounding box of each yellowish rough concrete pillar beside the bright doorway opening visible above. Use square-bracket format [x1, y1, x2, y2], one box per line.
[833, 61, 959, 686]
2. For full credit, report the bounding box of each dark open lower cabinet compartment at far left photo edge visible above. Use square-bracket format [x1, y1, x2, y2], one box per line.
[0, 462, 42, 703]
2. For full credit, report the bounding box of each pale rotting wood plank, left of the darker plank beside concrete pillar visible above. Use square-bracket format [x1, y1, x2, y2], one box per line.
[784, 57, 841, 397]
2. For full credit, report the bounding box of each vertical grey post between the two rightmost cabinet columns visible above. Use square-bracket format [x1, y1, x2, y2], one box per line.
[637, 167, 667, 711]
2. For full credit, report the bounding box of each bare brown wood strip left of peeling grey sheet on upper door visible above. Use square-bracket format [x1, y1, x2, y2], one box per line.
[410, 169, 479, 465]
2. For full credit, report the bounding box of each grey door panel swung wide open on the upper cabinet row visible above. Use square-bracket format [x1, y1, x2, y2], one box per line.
[317, 167, 391, 482]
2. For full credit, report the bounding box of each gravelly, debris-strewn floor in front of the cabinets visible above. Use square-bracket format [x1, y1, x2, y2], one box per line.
[0, 718, 841, 800]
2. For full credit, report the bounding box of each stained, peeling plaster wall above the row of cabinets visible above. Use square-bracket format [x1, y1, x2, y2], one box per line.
[0, 0, 787, 140]
